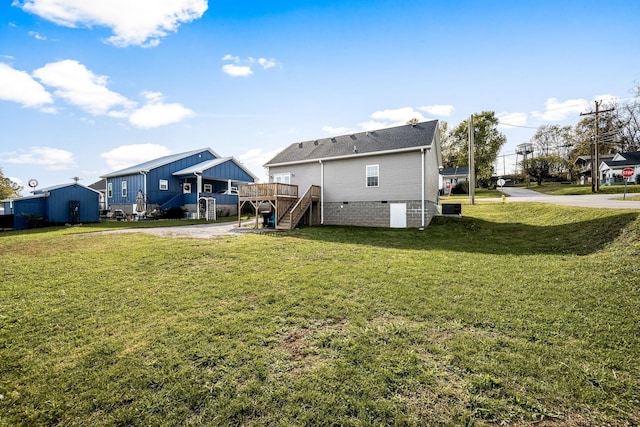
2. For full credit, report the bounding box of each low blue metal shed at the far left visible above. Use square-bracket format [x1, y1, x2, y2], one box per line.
[3, 183, 100, 230]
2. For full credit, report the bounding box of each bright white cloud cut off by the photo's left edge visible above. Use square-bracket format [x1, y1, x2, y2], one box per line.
[0, 62, 53, 108]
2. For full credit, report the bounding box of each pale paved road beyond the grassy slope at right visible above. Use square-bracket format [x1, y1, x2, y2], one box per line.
[500, 187, 640, 209]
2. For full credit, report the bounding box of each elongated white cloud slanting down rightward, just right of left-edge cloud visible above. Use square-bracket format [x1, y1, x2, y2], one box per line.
[33, 59, 134, 115]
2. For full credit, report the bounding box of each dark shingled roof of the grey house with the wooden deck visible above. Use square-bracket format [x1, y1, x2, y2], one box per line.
[265, 120, 438, 166]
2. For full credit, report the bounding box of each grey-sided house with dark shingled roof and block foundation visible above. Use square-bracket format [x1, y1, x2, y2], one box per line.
[252, 121, 441, 228]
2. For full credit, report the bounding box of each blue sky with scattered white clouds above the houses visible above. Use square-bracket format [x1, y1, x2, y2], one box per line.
[0, 0, 640, 194]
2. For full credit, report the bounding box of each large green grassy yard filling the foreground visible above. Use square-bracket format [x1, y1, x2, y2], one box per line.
[0, 203, 640, 426]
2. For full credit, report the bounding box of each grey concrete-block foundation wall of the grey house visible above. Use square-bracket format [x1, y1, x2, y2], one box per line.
[324, 200, 437, 228]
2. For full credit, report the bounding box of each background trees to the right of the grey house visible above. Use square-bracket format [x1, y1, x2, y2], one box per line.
[440, 84, 640, 186]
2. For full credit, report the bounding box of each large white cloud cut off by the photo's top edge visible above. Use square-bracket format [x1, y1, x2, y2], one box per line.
[14, 0, 208, 47]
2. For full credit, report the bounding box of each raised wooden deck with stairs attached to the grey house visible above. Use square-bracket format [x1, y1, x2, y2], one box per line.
[238, 182, 320, 230]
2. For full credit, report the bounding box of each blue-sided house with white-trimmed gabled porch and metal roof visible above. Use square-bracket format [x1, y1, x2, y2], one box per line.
[101, 148, 257, 219]
